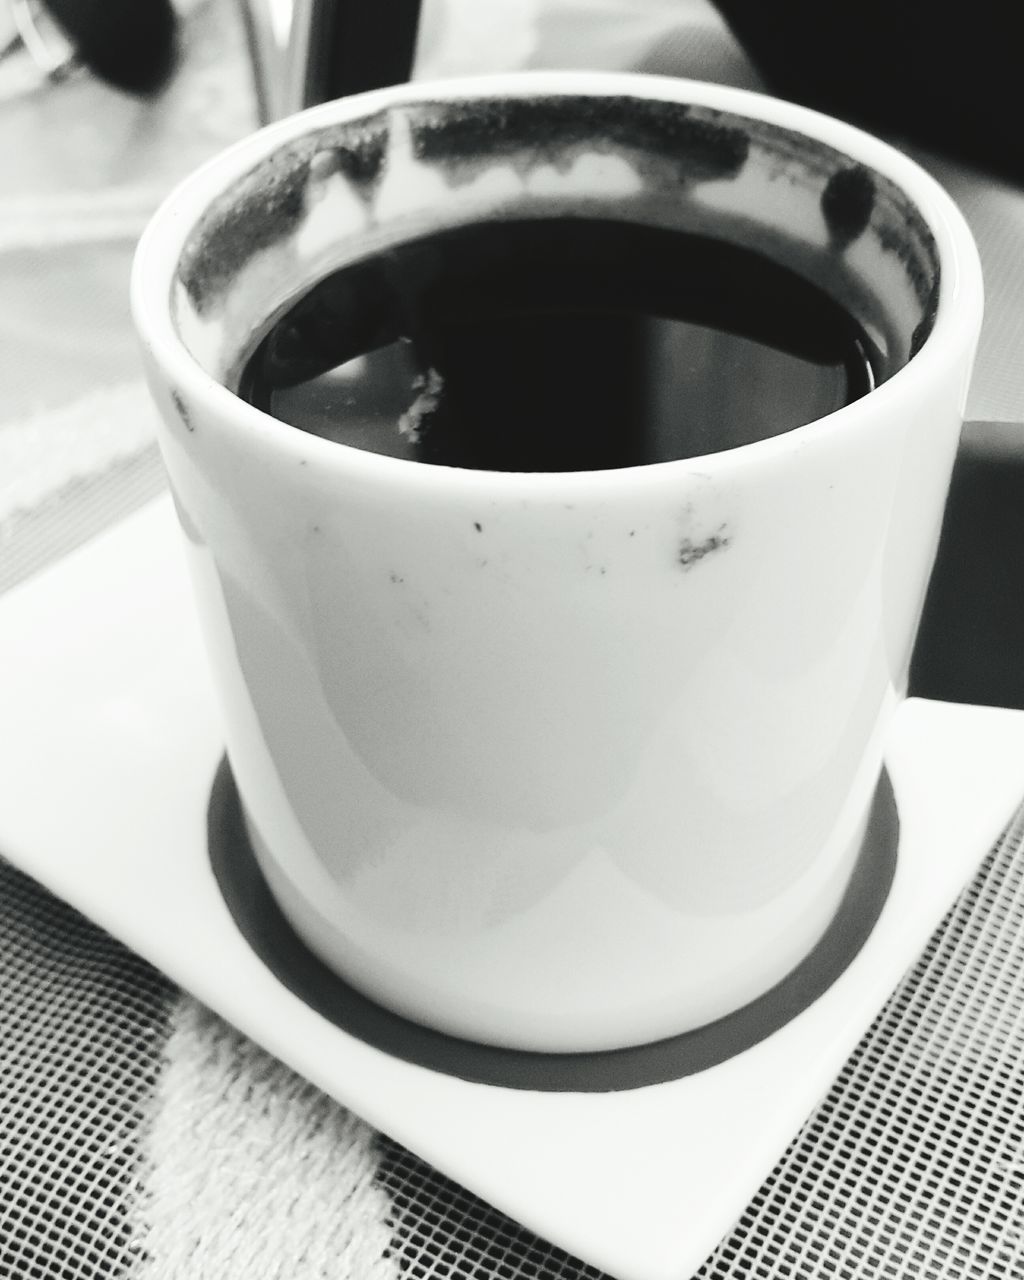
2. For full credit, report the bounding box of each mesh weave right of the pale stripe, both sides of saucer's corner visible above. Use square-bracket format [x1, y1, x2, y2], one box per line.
[371, 798, 1024, 1280]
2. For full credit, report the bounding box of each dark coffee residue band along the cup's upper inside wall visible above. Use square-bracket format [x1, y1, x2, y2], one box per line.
[170, 93, 940, 371]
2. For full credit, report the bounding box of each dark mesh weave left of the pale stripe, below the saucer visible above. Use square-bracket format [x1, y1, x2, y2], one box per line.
[0, 861, 172, 1280]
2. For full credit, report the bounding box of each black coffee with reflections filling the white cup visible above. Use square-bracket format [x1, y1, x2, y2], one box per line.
[239, 218, 879, 471]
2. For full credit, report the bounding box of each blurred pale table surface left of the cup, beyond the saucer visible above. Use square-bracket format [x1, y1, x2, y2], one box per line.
[0, 0, 257, 590]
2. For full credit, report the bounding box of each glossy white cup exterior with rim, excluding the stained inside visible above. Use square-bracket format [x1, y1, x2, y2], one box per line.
[133, 74, 982, 1051]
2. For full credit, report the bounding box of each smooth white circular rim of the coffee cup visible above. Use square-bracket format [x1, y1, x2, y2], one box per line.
[129, 70, 983, 497]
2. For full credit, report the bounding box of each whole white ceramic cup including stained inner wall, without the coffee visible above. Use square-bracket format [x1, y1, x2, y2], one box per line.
[133, 73, 982, 1051]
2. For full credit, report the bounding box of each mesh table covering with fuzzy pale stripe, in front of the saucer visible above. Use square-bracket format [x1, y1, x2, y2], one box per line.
[0, 757, 1024, 1280]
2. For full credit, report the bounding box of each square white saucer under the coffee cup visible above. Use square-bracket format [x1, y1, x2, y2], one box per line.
[0, 498, 1024, 1280]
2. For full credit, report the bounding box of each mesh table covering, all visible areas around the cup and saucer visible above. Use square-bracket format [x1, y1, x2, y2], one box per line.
[0, 0, 1024, 1280]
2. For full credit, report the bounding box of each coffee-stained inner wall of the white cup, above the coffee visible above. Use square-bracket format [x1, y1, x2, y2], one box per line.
[173, 93, 940, 389]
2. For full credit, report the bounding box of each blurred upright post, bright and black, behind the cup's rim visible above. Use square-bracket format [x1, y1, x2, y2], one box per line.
[241, 0, 420, 124]
